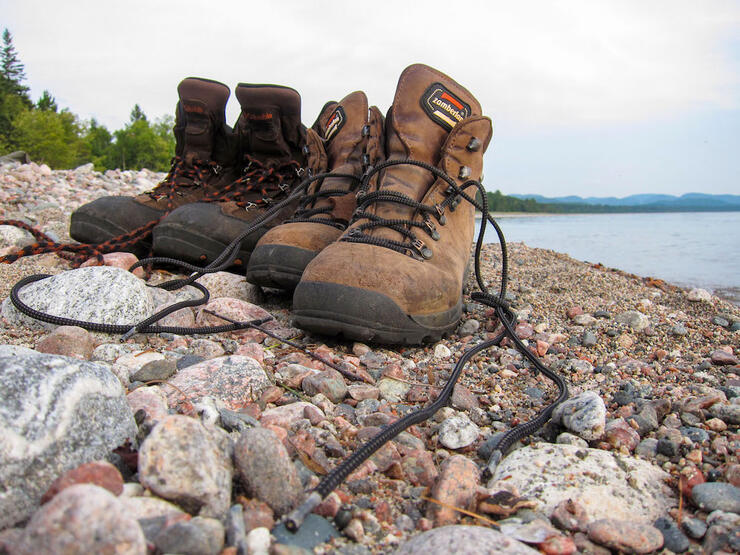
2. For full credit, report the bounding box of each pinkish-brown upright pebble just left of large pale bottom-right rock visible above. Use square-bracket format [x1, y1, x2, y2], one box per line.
[427, 455, 480, 527]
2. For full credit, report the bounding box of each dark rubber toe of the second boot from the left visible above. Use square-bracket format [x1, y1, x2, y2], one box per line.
[153, 220, 252, 266]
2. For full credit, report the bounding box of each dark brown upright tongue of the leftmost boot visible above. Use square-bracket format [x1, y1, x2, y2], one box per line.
[176, 77, 230, 164]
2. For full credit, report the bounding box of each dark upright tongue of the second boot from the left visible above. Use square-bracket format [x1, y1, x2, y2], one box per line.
[236, 83, 301, 165]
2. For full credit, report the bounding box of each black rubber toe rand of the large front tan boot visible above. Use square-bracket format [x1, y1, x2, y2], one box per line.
[293, 281, 462, 345]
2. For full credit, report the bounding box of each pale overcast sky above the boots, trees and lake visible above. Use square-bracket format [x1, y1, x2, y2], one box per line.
[0, 0, 740, 197]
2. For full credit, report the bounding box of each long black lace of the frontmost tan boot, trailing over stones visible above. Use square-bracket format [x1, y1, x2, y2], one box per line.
[5, 159, 568, 531]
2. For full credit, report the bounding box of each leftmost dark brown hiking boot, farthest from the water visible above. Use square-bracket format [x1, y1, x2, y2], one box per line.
[70, 77, 236, 254]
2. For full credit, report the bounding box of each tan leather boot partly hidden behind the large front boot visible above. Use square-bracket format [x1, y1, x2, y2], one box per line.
[247, 91, 383, 290]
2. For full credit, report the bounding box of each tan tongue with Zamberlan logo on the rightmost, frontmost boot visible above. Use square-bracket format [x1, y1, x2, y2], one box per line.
[374, 64, 481, 240]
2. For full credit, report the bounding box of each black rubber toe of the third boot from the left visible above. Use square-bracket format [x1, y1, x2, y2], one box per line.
[247, 245, 318, 291]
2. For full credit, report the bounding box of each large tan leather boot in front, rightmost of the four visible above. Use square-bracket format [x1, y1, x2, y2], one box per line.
[293, 65, 492, 344]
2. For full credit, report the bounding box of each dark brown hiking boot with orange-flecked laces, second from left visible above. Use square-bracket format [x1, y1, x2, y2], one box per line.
[154, 83, 325, 265]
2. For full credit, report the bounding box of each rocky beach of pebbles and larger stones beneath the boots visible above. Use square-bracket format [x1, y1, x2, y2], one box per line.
[0, 163, 740, 555]
